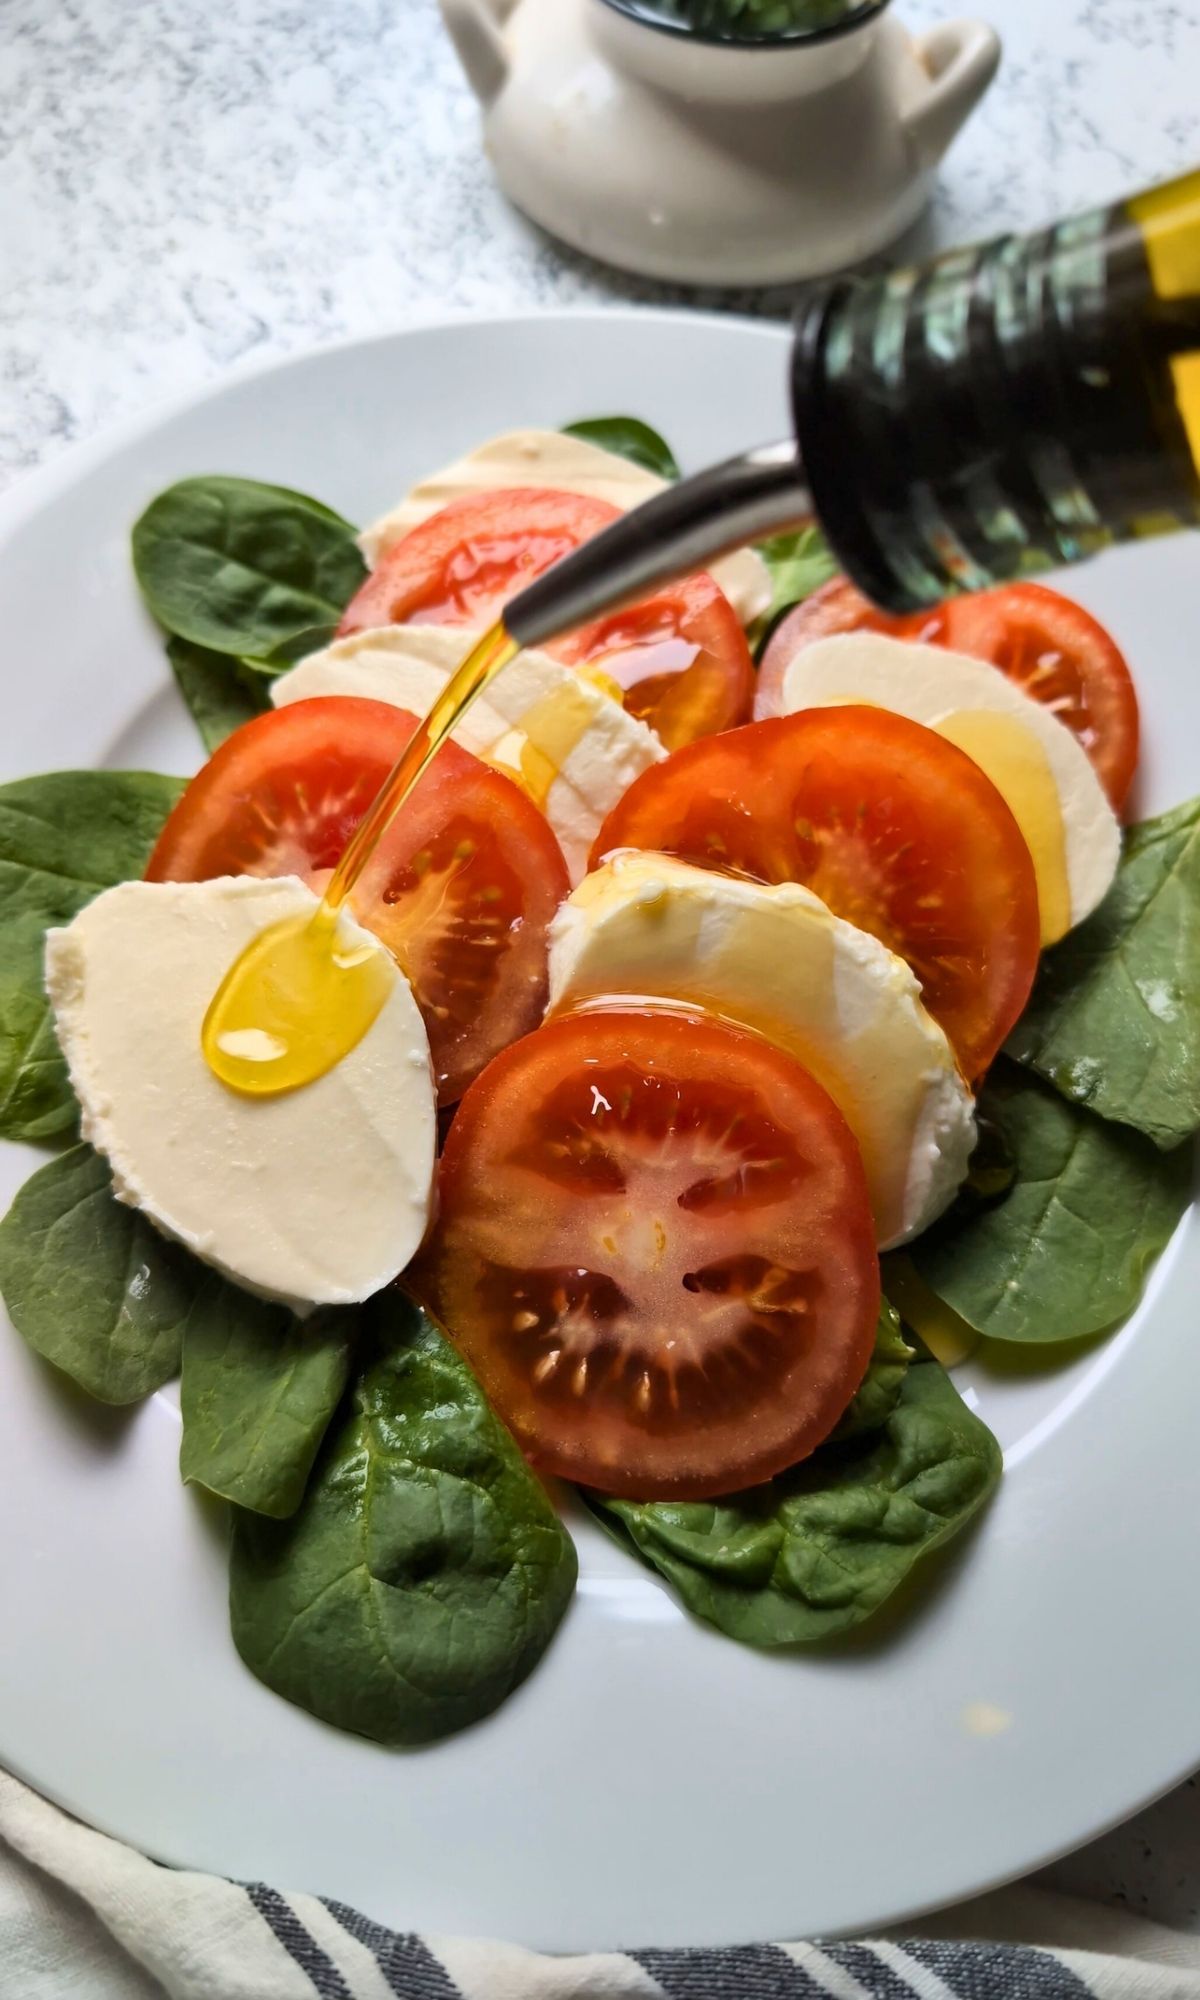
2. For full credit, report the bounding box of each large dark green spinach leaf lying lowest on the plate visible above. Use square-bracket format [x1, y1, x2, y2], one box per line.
[230, 1292, 576, 1744]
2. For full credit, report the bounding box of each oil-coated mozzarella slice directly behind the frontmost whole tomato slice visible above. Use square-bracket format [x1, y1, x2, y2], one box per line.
[550, 852, 976, 1248]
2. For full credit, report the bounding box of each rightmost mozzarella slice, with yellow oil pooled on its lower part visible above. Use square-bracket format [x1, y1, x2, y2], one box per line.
[782, 632, 1120, 944]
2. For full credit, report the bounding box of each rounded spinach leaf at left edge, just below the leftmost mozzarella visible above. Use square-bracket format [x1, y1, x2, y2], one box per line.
[0, 1146, 196, 1402]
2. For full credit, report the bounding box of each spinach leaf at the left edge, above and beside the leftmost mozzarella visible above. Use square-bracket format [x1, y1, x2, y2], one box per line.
[0, 770, 184, 1140]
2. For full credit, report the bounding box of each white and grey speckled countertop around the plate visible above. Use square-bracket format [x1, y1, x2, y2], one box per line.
[0, 0, 1200, 1930]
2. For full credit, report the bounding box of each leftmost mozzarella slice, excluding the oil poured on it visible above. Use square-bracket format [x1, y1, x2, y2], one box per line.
[46, 876, 438, 1312]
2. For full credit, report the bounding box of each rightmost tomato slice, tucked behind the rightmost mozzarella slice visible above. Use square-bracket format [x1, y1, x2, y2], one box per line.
[754, 576, 1138, 808]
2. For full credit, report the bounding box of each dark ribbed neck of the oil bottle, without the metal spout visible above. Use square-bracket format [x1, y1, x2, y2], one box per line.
[792, 174, 1200, 610]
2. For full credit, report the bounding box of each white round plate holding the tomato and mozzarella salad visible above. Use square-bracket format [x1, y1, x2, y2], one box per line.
[0, 312, 1200, 1950]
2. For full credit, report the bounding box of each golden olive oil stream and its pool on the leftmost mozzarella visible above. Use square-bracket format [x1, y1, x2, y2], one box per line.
[200, 622, 518, 1098]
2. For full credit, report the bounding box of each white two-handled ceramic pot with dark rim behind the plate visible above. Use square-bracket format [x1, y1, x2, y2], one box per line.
[442, 0, 1000, 284]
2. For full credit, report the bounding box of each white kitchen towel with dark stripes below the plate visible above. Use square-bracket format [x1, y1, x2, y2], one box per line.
[0, 1772, 1200, 2000]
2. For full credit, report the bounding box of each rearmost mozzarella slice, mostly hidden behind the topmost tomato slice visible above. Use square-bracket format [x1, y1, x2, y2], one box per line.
[358, 430, 772, 624]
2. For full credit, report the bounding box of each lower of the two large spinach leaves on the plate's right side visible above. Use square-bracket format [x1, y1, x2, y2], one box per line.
[910, 1062, 1192, 1342]
